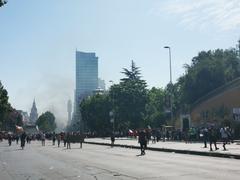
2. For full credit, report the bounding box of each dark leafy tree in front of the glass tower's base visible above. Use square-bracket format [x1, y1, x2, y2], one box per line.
[80, 94, 112, 135]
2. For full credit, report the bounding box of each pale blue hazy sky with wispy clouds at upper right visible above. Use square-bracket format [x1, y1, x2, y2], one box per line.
[0, 0, 240, 125]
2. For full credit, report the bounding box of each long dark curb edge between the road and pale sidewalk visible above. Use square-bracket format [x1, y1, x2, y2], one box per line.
[84, 141, 240, 159]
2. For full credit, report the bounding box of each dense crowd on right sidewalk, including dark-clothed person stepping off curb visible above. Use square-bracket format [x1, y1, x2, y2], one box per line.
[127, 126, 234, 155]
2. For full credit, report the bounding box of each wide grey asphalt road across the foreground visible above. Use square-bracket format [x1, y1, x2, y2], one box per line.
[0, 141, 240, 180]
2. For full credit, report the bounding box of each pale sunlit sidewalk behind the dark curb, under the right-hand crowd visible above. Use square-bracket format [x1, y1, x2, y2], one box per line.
[85, 138, 240, 159]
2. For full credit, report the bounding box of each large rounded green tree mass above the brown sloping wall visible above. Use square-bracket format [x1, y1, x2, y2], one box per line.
[176, 49, 240, 104]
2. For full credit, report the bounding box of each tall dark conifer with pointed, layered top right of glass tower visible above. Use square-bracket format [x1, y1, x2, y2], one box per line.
[110, 61, 147, 129]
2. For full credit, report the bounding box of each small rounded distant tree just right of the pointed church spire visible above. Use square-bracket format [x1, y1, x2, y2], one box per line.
[36, 111, 57, 132]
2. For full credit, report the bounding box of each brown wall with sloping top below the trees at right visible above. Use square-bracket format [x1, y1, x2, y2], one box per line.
[190, 78, 240, 135]
